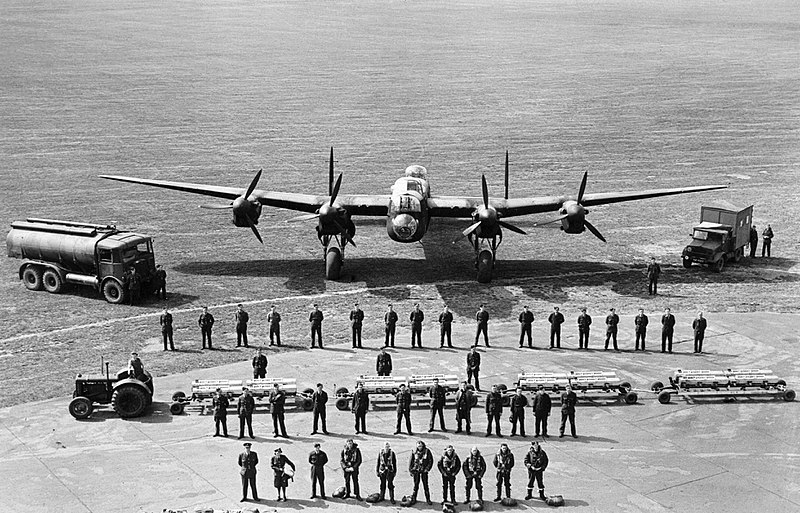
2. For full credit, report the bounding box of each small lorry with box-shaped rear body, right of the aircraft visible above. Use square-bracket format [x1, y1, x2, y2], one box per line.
[682, 205, 753, 272]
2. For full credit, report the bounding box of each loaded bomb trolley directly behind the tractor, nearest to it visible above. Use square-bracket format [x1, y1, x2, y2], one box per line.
[169, 378, 314, 415]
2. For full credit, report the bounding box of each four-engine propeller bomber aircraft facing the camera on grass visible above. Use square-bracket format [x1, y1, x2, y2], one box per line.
[100, 148, 727, 283]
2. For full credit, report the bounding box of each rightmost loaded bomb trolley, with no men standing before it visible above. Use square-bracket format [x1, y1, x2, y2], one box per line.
[650, 369, 796, 404]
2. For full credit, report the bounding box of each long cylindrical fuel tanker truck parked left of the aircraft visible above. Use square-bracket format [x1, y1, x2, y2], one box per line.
[6, 218, 156, 303]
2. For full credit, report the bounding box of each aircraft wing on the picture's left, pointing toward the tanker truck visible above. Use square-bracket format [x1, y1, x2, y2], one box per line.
[100, 175, 389, 216]
